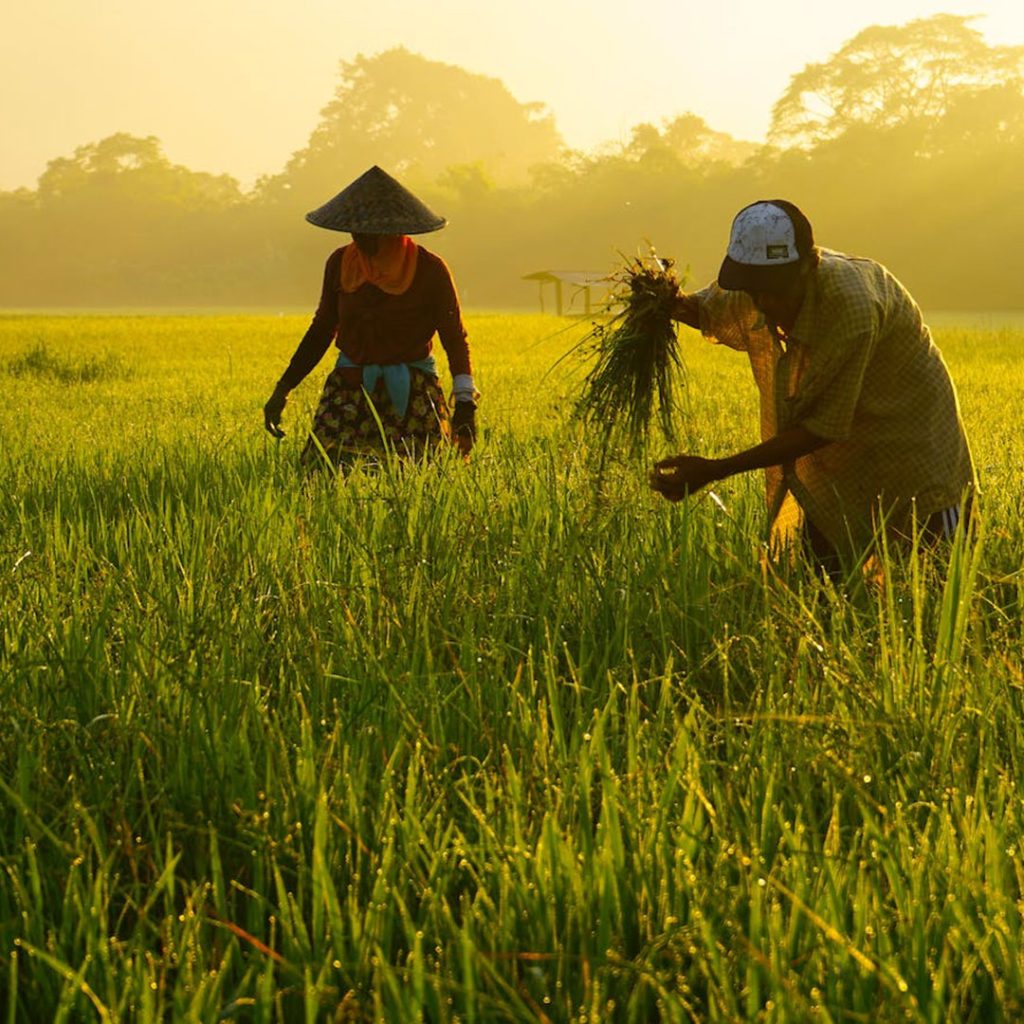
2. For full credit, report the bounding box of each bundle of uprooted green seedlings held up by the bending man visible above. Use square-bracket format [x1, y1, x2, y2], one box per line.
[573, 255, 683, 449]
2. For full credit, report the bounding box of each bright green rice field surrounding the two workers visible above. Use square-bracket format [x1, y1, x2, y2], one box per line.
[0, 314, 1024, 1024]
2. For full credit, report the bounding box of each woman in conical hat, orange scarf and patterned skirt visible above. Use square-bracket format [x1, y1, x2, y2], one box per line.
[263, 167, 478, 468]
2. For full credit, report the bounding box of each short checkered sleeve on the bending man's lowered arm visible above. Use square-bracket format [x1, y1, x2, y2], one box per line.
[787, 295, 880, 441]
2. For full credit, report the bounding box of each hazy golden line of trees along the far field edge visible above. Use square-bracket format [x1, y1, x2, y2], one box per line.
[0, 14, 1024, 308]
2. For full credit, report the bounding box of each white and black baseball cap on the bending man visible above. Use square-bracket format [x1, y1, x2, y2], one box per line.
[718, 199, 814, 292]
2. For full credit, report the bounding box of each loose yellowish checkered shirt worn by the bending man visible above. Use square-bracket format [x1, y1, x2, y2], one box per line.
[697, 250, 975, 550]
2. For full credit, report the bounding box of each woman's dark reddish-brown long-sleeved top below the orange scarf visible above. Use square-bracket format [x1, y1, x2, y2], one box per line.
[279, 246, 472, 391]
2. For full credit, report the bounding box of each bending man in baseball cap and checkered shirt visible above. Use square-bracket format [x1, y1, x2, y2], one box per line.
[650, 200, 975, 575]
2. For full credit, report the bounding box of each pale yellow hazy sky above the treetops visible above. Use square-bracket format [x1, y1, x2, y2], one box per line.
[6, 0, 1024, 188]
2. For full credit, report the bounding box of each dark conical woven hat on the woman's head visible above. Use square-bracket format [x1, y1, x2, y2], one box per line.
[306, 166, 447, 234]
